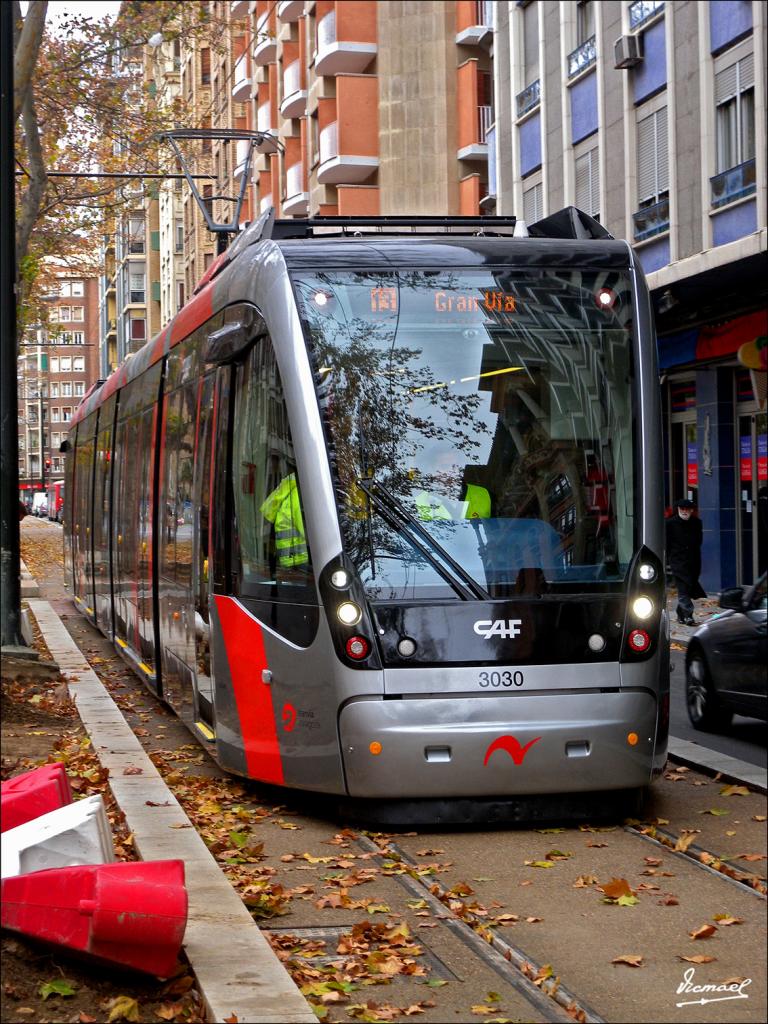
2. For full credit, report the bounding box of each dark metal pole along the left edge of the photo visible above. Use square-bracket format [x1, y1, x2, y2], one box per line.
[0, 3, 25, 647]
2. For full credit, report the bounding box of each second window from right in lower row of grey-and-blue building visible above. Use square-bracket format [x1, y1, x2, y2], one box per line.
[634, 106, 670, 242]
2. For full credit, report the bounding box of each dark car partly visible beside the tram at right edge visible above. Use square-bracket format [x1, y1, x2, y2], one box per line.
[685, 573, 768, 732]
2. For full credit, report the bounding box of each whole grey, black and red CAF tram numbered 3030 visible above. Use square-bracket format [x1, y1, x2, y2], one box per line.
[65, 208, 669, 819]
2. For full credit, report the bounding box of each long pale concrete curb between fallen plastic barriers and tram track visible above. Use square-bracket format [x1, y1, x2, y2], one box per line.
[30, 600, 317, 1024]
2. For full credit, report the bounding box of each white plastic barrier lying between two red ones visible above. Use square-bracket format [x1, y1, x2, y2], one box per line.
[0, 797, 115, 879]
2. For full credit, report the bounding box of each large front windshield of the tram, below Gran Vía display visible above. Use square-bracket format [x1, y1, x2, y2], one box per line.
[294, 268, 635, 600]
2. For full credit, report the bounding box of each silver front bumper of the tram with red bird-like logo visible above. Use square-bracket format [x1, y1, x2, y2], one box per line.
[339, 690, 656, 799]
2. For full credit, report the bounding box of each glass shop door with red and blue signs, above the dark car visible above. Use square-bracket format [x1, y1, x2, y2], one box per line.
[738, 413, 768, 585]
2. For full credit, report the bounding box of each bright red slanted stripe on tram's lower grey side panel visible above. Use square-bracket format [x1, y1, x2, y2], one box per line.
[215, 597, 284, 783]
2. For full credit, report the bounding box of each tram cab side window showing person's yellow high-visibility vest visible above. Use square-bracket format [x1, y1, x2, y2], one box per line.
[231, 339, 315, 602]
